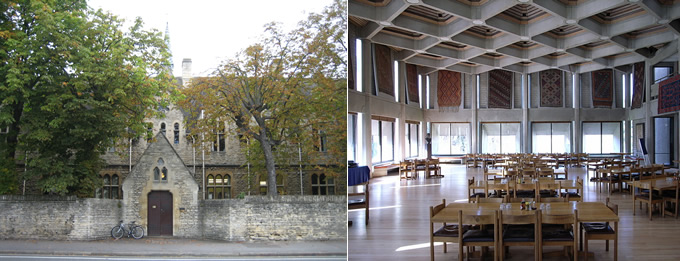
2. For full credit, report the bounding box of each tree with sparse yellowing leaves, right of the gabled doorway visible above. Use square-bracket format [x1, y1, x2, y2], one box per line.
[180, 0, 347, 195]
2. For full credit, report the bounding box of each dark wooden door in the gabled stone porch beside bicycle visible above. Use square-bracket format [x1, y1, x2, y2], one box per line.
[148, 191, 172, 236]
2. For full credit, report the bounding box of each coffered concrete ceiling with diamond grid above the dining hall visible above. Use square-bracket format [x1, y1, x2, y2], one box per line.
[349, 0, 680, 74]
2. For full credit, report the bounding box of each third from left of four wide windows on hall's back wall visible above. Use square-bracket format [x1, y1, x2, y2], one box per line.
[531, 122, 571, 153]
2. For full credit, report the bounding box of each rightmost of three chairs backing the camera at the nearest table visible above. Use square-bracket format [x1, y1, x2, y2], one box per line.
[538, 210, 578, 261]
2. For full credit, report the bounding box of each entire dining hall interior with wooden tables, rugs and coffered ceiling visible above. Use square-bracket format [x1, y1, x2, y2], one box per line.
[347, 0, 680, 260]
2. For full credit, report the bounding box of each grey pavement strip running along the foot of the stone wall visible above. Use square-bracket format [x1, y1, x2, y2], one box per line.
[0, 237, 347, 257]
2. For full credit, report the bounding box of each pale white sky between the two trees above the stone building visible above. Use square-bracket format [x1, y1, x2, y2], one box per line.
[88, 0, 333, 76]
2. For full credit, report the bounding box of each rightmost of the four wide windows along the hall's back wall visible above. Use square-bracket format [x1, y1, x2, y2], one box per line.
[583, 122, 621, 154]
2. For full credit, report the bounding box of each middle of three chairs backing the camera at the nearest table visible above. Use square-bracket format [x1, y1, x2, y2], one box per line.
[498, 210, 541, 260]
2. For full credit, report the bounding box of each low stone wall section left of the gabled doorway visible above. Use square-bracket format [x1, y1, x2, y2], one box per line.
[0, 195, 121, 240]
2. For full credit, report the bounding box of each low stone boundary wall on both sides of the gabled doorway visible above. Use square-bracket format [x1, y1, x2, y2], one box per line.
[0, 196, 347, 241]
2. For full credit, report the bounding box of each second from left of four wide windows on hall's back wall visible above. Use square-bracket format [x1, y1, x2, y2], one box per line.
[482, 122, 521, 153]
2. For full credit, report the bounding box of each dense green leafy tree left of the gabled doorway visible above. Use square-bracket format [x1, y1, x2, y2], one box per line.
[0, 0, 172, 196]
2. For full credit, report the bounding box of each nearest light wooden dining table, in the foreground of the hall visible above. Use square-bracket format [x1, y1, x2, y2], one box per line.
[432, 201, 619, 260]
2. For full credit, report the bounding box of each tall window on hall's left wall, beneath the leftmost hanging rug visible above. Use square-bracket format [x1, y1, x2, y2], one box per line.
[371, 116, 394, 163]
